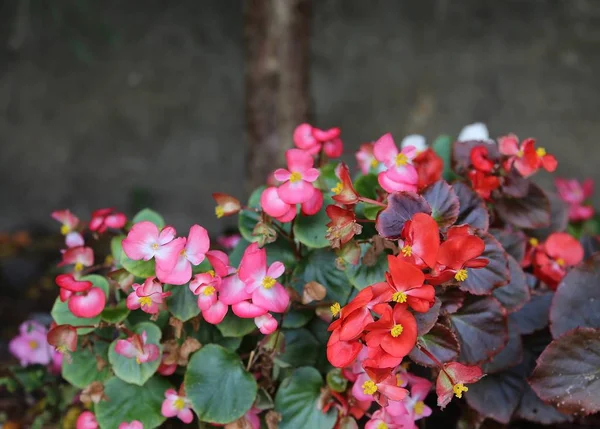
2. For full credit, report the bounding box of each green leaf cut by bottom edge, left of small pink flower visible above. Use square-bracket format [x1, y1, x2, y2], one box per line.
[95, 377, 173, 429]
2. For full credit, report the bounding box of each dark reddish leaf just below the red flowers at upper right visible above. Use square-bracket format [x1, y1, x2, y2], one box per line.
[495, 183, 550, 229]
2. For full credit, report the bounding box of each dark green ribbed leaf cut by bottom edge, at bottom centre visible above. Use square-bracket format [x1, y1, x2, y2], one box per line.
[275, 367, 337, 429]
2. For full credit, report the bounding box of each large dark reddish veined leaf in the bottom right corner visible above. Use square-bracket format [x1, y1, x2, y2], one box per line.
[529, 328, 600, 415]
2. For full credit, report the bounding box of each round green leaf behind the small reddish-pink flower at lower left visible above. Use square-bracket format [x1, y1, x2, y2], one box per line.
[108, 322, 162, 386]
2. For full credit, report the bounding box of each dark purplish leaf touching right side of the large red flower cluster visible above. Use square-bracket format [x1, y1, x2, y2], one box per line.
[459, 231, 510, 295]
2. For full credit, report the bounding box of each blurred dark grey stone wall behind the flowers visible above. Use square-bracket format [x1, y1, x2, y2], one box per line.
[0, 0, 600, 234]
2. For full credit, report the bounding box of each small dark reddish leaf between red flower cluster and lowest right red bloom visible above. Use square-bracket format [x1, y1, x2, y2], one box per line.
[408, 323, 459, 367]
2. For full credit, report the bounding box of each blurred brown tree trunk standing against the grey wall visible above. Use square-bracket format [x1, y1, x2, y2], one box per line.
[244, 0, 311, 190]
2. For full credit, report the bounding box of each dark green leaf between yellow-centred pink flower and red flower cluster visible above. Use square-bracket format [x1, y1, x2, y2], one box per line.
[293, 249, 352, 305]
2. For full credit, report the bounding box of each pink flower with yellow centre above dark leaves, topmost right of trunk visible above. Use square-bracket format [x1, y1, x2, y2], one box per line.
[373, 133, 419, 192]
